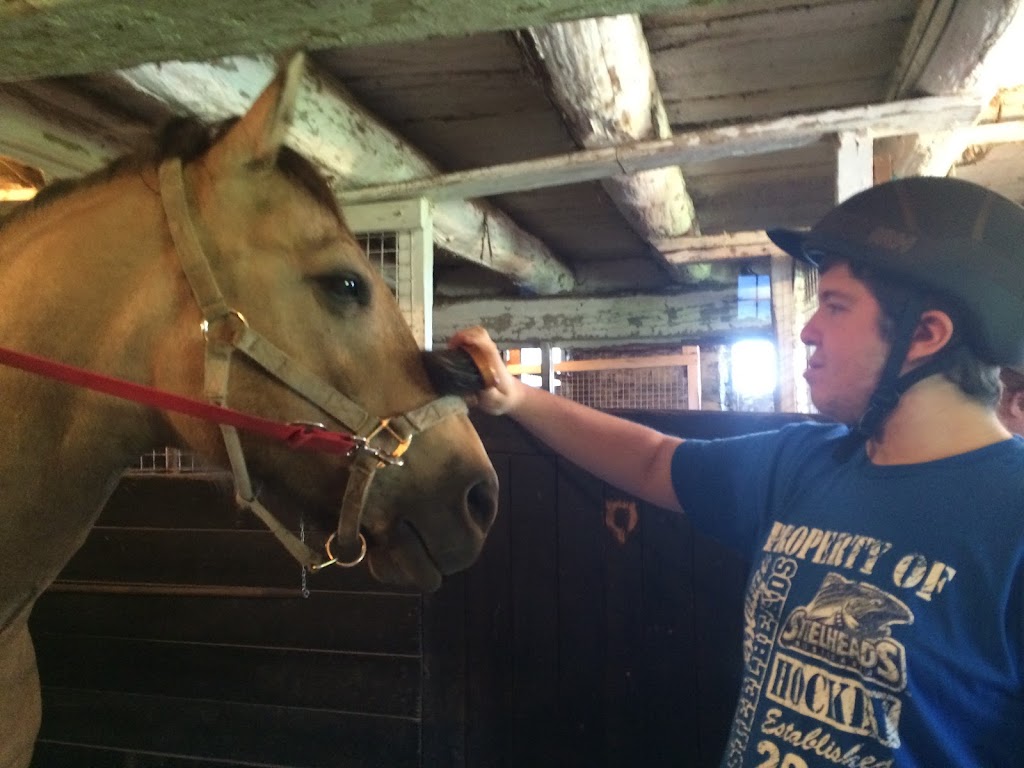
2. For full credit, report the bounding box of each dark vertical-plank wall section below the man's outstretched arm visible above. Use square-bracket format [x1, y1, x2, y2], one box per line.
[445, 412, 806, 768]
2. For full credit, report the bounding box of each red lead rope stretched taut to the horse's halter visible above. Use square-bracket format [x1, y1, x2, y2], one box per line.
[0, 347, 355, 454]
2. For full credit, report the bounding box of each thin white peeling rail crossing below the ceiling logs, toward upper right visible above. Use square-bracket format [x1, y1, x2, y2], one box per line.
[340, 95, 977, 203]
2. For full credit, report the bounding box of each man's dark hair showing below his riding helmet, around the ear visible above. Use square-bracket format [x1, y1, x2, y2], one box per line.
[821, 258, 999, 408]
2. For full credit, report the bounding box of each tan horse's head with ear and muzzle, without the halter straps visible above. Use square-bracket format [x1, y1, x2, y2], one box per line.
[137, 56, 497, 589]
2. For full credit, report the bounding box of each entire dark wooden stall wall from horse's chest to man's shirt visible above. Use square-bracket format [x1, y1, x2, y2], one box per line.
[32, 412, 806, 768]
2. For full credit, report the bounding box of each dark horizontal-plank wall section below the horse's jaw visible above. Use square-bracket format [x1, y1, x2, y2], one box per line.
[31, 477, 424, 768]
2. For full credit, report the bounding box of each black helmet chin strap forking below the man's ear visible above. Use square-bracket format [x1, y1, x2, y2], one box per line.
[836, 296, 955, 461]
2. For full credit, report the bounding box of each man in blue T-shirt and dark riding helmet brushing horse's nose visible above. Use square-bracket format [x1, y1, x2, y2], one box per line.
[453, 178, 1024, 768]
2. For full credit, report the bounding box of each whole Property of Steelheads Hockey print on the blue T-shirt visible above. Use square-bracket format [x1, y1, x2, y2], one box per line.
[722, 522, 956, 768]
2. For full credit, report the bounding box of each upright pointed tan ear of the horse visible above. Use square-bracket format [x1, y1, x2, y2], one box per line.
[210, 51, 306, 167]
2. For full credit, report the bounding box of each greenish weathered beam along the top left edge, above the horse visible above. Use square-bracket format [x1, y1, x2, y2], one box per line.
[0, 0, 729, 82]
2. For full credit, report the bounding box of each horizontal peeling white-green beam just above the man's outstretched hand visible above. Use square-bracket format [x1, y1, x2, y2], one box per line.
[434, 287, 772, 347]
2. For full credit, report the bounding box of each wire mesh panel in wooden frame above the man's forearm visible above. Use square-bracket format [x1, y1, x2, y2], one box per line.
[558, 347, 689, 411]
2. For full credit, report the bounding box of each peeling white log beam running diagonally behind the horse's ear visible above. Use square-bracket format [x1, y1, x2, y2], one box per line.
[119, 56, 574, 294]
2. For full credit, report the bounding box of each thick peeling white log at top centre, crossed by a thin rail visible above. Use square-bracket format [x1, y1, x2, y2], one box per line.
[520, 15, 694, 278]
